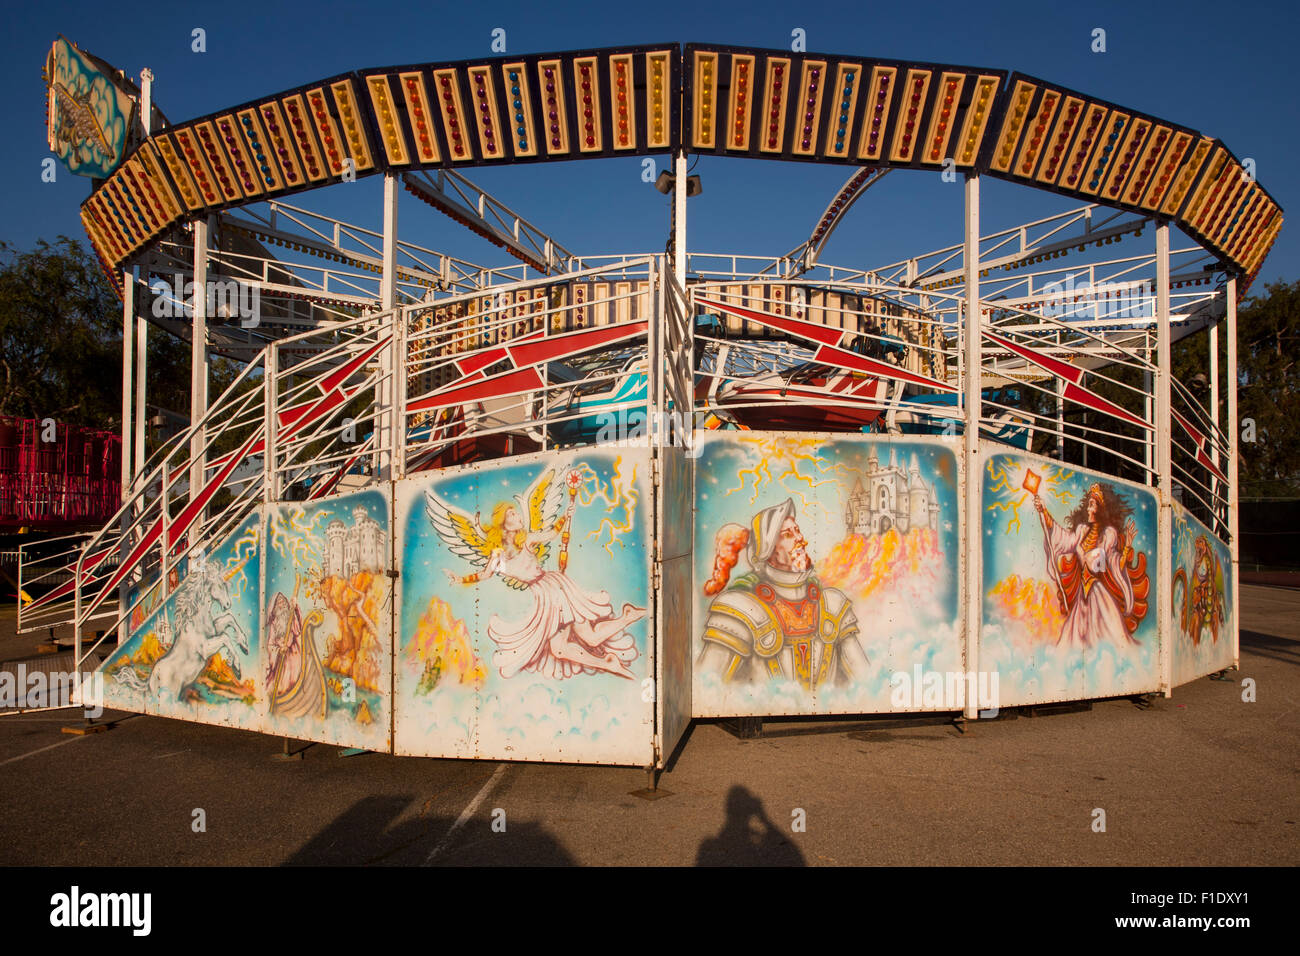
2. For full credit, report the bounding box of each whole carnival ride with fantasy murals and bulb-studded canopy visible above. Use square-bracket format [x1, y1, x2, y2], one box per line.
[21, 39, 1282, 769]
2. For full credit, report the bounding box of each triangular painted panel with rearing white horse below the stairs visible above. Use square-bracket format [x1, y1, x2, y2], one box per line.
[100, 514, 265, 730]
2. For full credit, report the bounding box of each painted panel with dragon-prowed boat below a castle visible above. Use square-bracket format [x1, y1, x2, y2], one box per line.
[261, 490, 393, 750]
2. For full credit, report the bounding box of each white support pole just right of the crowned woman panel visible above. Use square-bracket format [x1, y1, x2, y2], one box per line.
[1154, 222, 1174, 697]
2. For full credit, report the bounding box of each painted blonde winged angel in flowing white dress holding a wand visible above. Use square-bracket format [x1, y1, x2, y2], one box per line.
[425, 470, 645, 679]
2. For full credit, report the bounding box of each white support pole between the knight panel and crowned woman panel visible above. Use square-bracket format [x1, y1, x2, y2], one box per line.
[962, 173, 984, 721]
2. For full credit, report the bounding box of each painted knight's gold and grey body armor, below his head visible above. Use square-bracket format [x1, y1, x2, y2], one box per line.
[703, 566, 866, 689]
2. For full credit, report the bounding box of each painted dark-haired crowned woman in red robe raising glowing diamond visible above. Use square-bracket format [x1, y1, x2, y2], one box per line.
[1026, 483, 1151, 646]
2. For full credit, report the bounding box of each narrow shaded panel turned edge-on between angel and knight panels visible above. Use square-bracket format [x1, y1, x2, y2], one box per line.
[655, 446, 696, 767]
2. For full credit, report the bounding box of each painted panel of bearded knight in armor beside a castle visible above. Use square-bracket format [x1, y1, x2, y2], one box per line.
[693, 432, 963, 717]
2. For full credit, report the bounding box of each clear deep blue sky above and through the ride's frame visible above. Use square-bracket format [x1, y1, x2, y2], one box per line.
[0, 0, 1300, 291]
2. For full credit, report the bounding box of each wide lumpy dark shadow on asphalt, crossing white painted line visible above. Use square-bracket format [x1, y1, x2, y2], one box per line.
[281, 795, 576, 866]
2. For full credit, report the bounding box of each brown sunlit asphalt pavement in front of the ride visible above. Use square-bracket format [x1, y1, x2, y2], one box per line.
[0, 585, 1300, 866]
